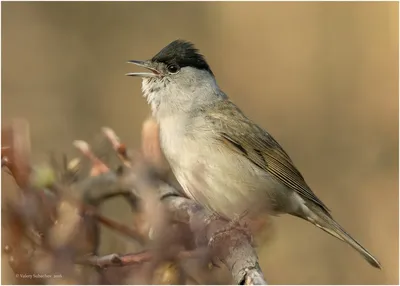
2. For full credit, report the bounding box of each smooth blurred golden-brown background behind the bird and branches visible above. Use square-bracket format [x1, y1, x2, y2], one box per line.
[1, 2, 399, 284]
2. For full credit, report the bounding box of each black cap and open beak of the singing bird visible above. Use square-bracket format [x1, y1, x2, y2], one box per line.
[126, 40, 213, 77]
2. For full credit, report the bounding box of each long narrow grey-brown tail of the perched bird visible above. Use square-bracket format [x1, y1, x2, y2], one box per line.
[305, 206, 381, 269]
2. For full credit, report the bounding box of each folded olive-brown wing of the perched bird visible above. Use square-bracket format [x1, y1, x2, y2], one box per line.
[207, 100, 329, 213]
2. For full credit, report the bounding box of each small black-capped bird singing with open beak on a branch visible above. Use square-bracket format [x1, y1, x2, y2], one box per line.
[127, 40, 381, 268]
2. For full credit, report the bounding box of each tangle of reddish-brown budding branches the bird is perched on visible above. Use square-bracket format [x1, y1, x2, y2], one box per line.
[1, 119, 266, 285]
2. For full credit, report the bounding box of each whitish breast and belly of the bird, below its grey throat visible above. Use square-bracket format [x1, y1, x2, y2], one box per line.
[160, 115, 280, 217]
